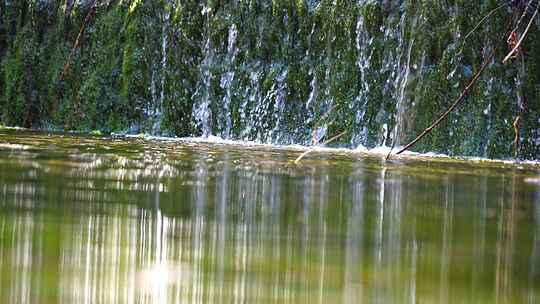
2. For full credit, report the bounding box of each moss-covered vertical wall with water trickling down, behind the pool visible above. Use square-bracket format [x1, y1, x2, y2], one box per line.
[0, 0, 540, 159]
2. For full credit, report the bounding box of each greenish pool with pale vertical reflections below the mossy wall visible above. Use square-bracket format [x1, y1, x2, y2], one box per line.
[0, 130, 540, 303]
